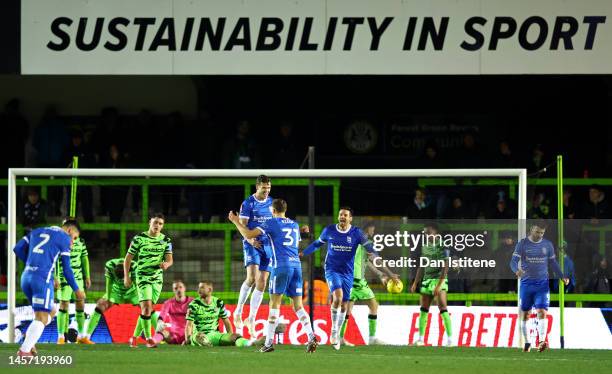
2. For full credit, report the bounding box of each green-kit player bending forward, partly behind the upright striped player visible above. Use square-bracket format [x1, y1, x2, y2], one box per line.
[79, 257, 138, 344]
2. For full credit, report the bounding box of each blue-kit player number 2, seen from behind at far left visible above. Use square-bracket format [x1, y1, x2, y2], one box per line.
[13, 220, 85, 356]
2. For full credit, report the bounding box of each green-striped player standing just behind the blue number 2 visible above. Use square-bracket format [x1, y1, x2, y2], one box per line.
[55, 237, 91, 344]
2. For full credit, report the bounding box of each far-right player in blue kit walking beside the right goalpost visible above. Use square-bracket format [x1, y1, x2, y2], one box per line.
[510, 221, 569, 352]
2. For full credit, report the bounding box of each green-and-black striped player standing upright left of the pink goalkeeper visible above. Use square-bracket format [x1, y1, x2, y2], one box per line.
[123, 213, 173, 348]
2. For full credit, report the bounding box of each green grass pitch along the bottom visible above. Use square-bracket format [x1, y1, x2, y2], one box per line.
[0, 344, 612, 374]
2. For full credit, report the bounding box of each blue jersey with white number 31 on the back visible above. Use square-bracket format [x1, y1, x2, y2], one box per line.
[257, 217, 301, 268]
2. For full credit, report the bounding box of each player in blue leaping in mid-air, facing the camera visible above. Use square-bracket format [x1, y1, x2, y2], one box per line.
[234, 175, 272, 336]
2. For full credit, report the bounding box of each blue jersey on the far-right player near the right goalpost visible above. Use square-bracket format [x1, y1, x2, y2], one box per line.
[510, 238, 562, 282]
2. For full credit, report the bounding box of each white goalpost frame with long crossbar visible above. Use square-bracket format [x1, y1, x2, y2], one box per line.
[7, 168, 527, 343]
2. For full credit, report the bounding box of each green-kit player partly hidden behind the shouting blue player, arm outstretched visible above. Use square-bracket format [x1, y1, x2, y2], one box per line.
[340, 222, 399, 347]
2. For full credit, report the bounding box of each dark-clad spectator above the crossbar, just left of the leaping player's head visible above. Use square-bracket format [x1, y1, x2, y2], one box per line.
[223, 120, 261, 169]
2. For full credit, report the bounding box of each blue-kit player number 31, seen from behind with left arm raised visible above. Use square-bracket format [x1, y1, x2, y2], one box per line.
[228, 199, 318, 353]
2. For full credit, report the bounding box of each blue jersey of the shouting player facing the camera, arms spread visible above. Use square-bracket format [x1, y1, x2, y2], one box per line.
[319, 225, 368, 275]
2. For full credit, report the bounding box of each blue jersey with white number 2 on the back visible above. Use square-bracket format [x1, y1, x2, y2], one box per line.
[15, 226, 72, 282]
